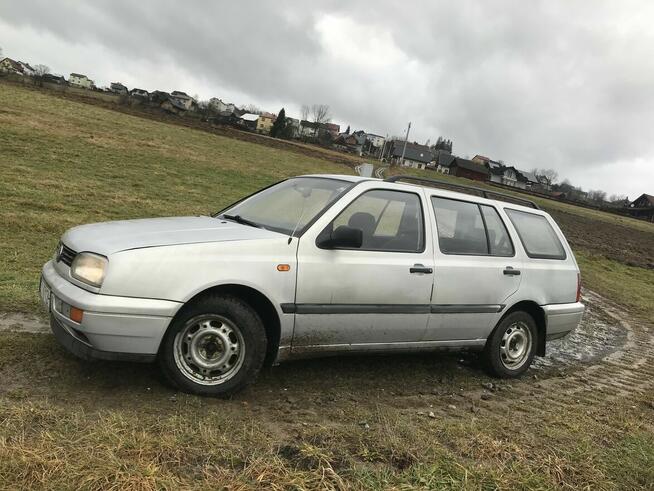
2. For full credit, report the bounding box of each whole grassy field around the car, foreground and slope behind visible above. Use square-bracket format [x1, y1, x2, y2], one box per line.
[0, 84, 654, 490]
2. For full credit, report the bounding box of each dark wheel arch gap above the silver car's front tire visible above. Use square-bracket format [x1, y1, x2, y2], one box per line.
[175, 283, 281, 365]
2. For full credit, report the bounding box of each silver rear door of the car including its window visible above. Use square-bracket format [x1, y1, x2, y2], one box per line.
[425, 193, 523, 341]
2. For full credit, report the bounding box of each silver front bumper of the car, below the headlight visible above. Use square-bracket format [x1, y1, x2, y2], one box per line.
[41, 261, 182, 361]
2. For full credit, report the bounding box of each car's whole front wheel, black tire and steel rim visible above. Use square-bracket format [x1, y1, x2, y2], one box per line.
[158, 295, 267, 397]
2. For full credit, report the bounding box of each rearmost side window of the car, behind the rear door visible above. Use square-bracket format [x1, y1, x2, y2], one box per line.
[505, 209, 566, 259]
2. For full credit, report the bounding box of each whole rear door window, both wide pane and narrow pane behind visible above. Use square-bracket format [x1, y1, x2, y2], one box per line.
[431, 197, 513, 256]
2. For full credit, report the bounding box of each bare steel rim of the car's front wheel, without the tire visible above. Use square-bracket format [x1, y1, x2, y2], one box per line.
[174, 314, 245, 385]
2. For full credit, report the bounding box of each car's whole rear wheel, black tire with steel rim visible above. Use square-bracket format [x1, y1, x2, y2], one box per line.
[484, 311, 538, 378]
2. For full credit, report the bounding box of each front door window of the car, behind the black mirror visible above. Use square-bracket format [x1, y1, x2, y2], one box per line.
[323, 189, 425, 252]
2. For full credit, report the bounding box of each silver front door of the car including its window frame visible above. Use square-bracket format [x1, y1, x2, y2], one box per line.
[293, 186, 434, 351]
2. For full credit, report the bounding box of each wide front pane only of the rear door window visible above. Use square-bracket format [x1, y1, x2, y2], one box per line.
[431, 197, 488, 255]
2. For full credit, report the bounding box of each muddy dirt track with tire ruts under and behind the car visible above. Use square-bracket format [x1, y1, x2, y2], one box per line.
[0, 291, 654, 419]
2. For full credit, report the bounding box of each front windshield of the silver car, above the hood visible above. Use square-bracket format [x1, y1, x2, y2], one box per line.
[217, 177, 353, 236]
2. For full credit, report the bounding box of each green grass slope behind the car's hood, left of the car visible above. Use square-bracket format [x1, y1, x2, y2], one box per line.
[0, 85, 353, 311]
